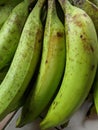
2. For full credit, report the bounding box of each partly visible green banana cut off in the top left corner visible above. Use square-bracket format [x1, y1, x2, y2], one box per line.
[0, 0, 22, 29]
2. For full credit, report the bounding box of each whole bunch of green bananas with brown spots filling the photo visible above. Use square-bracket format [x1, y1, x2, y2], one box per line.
[0, 0, 98, 130]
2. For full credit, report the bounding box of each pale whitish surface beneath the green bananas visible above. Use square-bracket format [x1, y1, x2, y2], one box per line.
[5, 101, 98, 130]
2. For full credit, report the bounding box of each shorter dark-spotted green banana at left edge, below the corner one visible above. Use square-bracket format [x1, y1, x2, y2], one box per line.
[0, 2, 28, 69]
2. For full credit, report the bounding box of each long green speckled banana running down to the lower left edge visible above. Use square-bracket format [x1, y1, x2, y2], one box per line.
[0, 0, 44, 120]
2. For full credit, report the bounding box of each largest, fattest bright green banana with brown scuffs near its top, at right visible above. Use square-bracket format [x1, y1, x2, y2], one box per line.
[40, 0, 98, 129]
